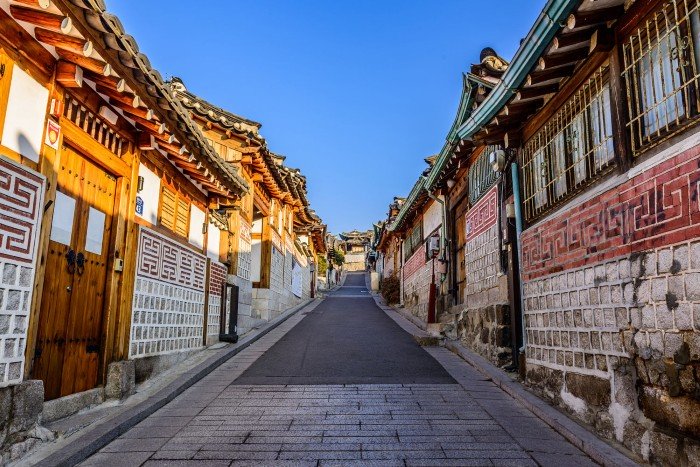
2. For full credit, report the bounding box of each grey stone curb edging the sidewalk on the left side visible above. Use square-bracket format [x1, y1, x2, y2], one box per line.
[32, 299, 321, 466]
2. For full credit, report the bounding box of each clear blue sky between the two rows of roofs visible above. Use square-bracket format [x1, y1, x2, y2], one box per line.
[107, 0, 545, 233]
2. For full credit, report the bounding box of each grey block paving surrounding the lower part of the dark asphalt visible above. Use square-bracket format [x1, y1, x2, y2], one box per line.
[75, 274, 608, 467]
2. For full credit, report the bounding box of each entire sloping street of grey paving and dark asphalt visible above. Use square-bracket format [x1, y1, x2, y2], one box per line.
[84, 275, 594, 467]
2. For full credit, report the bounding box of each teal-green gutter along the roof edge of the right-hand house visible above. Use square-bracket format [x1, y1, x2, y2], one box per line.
[425, 0, 580, 187]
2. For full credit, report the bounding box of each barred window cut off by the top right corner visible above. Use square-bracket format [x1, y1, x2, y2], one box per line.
[623, 0, 700, 156]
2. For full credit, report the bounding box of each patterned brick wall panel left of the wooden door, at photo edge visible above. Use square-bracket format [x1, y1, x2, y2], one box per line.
[0, 156, 44, 387]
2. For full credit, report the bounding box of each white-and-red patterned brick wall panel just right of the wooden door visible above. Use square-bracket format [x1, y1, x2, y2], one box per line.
[129, 227, 206, 358]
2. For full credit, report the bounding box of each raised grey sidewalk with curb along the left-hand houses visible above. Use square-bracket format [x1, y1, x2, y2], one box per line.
[18, 299, 321, 466]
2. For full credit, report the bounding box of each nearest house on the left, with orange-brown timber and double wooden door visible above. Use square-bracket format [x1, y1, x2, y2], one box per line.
[0, 0, 247, 456]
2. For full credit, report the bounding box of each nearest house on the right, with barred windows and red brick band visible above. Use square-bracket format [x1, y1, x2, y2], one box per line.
[418, 0, 700, 465]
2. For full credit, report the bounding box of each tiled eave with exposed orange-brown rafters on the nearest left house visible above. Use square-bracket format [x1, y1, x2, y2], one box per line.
[0, 0, 248, 197]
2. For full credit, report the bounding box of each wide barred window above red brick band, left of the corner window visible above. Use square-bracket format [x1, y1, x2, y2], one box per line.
[521, 65, 615, 220]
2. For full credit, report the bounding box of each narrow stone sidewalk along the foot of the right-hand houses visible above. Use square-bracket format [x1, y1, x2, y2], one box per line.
[372, 293, 638, 466]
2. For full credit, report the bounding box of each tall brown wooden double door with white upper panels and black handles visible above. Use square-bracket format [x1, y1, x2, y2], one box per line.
[32, 146, 116, 400]
